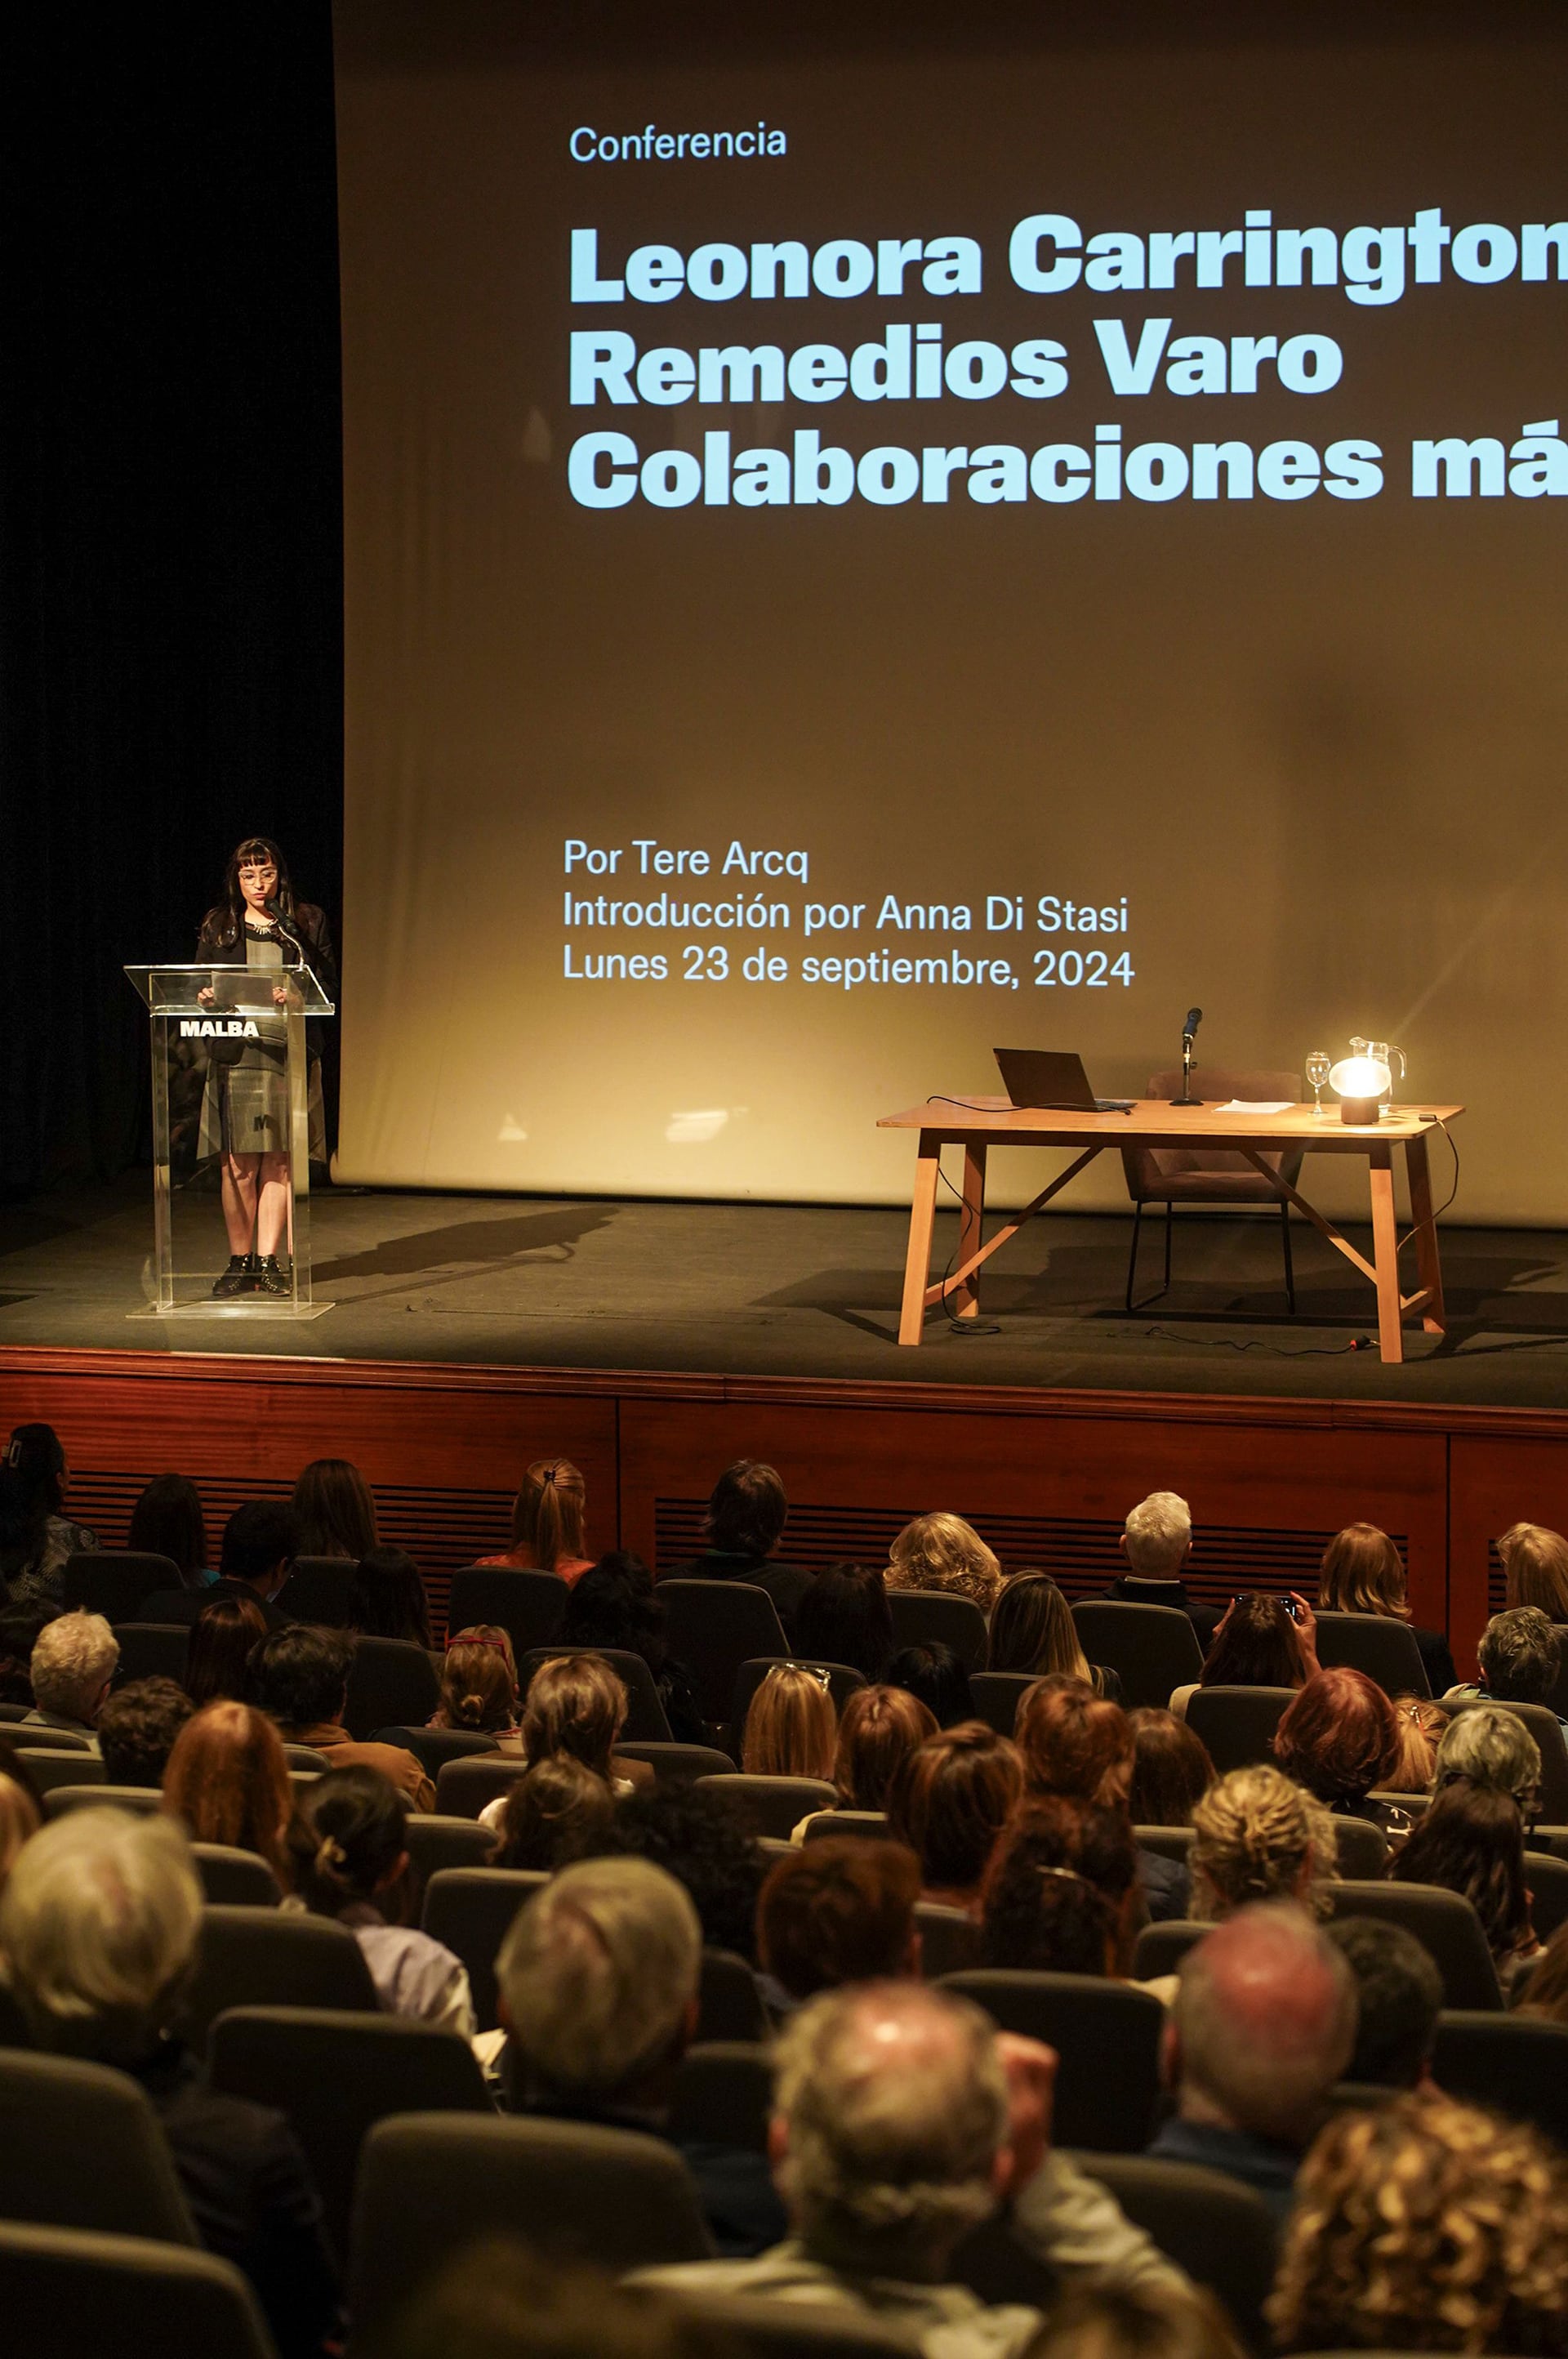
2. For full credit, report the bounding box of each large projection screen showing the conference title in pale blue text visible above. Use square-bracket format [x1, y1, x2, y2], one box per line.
[337, 0, 1568, 1222]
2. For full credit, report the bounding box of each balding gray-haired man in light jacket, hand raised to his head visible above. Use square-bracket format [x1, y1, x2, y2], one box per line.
[644, 1982, 1186, 2359]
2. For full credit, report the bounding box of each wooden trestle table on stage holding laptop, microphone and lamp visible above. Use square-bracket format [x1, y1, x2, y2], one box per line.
[877, 1097, 1464, 1361]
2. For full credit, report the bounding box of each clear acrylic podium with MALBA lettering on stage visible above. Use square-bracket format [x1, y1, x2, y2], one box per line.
[125, 962, 335, 1318]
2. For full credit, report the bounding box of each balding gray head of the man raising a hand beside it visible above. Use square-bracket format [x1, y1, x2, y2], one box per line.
[773, 1982, 1007, 2277]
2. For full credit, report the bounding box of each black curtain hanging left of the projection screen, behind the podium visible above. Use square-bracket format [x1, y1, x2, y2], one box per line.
[0, 0, 342, 1198]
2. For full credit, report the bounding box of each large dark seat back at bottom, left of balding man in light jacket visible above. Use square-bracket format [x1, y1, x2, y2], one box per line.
[349, 2114, 712, 2349]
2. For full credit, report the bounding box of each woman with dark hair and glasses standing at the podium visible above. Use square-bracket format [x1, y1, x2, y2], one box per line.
[196, 835, 337, 1297]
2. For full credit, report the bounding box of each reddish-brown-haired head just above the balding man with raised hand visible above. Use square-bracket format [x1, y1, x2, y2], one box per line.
[757, 1835, 920, 2014]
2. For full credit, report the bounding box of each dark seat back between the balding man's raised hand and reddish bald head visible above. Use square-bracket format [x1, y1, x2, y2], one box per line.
[943, 1968, 1165, 2154]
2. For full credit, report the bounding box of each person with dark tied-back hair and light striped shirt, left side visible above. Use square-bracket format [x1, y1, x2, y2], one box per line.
[297, 1769, 474, 2040]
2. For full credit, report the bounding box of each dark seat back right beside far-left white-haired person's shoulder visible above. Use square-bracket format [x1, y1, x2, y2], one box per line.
[207, 2008, 495, 2258]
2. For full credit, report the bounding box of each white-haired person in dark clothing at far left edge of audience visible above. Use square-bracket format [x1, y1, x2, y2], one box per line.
[0, 1809, 340, 2359]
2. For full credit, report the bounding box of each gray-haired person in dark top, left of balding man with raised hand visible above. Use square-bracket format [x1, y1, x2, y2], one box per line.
[495, 1859, 785, 2255]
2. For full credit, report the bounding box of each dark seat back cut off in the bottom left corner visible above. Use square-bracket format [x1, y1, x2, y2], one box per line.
[0, 2220, 276, 2359]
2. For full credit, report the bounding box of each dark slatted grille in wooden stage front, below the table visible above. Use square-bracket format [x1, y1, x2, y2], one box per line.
[653, 1498, 1408, 1607]
